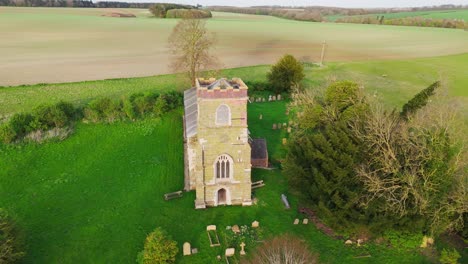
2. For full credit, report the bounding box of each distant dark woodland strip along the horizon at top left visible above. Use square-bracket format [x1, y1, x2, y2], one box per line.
[0, 0, 154, 8]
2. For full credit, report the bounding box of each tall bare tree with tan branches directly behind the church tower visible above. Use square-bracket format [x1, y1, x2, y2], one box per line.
[169, 17, 218, 85]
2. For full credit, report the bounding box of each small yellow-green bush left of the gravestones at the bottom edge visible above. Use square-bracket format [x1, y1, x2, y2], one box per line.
[137, 227, 179, 264]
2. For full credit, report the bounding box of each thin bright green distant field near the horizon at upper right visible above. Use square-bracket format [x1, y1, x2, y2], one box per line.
[326, 9, 468, 21]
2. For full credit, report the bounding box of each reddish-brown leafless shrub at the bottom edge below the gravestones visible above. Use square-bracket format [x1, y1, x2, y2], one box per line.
[242, 235, 318, 264]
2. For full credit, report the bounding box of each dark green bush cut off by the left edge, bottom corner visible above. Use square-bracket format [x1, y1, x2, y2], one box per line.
[0, 208, 24, 263]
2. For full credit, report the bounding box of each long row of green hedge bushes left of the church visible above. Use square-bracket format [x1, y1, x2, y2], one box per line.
[0, 92, 183, 144]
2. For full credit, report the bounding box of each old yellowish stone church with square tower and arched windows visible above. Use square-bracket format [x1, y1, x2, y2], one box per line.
[184, 78, 268, 209]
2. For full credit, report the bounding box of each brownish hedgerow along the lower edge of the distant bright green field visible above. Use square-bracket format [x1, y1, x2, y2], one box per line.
[336, 15, 467, 29]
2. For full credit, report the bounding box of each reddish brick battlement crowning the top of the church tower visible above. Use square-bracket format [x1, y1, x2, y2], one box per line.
[195, 78, 249, 99]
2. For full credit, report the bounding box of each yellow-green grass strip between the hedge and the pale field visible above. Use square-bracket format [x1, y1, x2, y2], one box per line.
[0, 53, 468, 120]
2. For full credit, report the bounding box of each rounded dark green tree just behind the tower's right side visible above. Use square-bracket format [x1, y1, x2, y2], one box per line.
[267, 55, 305, 94]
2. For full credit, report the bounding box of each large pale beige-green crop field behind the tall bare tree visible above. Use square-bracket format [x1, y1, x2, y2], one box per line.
[0, 7, 468, 86]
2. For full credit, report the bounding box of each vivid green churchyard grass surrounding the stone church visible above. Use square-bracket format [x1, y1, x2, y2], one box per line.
[0, 101, 436, 264]
